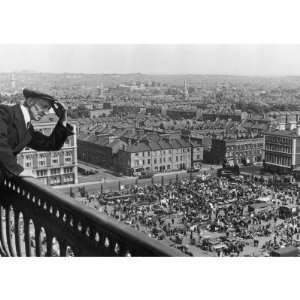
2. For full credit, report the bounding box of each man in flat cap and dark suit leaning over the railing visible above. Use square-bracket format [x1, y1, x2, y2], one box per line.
[0, 89, 73, 177]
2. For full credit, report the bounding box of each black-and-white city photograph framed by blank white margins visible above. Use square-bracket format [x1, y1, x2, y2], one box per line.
[0, 44, 300, 257]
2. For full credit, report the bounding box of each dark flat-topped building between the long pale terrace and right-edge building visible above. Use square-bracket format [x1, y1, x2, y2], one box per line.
[204, 138, 264, 165]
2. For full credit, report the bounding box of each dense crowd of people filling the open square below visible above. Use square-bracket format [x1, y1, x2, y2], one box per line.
[79, 176, 300, 256]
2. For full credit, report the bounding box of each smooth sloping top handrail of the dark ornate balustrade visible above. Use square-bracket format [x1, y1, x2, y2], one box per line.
[7, 177, 185, 257]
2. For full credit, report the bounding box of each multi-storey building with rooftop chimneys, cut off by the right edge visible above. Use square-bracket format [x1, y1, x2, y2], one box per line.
[264, 122, 300, 174]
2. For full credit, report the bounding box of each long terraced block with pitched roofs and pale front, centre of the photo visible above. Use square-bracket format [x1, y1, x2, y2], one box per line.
[78, 129, 199, 175]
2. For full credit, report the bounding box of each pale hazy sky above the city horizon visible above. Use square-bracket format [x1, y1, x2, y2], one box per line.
[0, 44, 300, 76]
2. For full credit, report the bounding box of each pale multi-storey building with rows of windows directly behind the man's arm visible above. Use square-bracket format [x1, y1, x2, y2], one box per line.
[17, 121, 78, 185]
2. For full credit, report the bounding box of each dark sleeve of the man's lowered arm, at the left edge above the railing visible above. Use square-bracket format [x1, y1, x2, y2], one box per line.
[0, 107, 24, 177]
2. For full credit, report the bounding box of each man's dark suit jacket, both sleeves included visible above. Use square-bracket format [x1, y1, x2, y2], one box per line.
[0, 105, 73, 177]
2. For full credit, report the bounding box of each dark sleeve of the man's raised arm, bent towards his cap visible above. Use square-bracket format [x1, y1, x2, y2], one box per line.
[28, 123, 74, 151]
